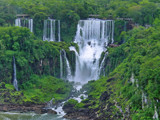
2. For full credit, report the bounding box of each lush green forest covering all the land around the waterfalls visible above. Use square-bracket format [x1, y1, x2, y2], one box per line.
[0, 0, 160, 120]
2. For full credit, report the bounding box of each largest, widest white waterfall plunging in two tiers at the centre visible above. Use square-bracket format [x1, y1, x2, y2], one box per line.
[72, 19, 114, 84]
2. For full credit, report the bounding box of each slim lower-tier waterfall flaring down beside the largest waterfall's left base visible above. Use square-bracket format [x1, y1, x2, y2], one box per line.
[60, 50, 72, 80]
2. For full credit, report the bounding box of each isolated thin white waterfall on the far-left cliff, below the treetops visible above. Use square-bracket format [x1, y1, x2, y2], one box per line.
[13, 56, 18, 91]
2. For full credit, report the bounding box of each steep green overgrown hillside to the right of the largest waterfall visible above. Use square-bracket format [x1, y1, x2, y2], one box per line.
[82, 23, 160, 120]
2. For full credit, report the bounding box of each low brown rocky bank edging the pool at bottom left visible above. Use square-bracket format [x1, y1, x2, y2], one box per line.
[0, 104, 57, 114]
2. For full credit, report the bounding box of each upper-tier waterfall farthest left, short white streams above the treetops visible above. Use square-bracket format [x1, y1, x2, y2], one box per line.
[15, 18, 33, 32]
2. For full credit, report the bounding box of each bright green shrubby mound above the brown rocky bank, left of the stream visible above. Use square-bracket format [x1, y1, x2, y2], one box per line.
[22, 75, 72, 103]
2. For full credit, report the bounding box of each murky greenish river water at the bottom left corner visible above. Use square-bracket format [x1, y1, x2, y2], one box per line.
[0, 112, 67, 120]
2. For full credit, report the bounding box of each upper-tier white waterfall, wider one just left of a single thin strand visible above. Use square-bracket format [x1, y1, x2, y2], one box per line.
[43, 19, 55, 41]
